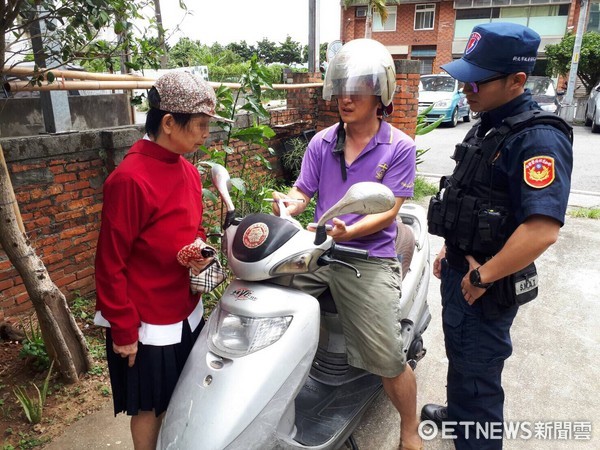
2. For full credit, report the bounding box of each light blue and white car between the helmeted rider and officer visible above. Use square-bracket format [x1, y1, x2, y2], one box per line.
[419, 74, 471, 127]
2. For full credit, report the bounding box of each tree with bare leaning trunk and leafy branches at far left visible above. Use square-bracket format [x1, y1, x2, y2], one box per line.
[0, 0, 176, 383]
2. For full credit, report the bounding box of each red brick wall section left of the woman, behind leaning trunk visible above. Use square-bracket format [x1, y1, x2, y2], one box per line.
[0, 132, 105, 316]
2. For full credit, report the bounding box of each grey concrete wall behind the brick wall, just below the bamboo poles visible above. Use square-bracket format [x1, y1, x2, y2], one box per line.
[0, 94, 130, 137]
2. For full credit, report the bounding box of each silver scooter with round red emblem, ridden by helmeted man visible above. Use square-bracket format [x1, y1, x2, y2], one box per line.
[157, 166, 431, 450]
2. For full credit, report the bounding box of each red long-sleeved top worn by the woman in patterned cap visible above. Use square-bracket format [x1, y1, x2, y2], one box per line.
[96, 140, 206, 345]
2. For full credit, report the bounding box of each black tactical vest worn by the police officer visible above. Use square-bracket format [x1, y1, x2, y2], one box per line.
[427, 110, 573, 256]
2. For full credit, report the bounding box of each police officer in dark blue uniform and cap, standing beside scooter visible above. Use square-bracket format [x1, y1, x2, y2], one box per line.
[421, 22, 573, 450]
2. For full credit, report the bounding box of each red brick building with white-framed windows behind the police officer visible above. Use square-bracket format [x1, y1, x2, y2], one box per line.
[340, 0, 588, 75]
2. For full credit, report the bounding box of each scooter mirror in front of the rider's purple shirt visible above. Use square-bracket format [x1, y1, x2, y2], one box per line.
[317, 181, 396, 226]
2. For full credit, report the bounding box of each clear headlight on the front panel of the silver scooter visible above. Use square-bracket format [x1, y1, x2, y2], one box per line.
[209, 306, 292, 357]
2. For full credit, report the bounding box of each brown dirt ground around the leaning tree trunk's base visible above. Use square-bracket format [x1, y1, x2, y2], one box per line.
[0, 302, 111, 450]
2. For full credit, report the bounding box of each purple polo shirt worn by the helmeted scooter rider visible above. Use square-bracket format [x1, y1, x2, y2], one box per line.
[294, 121, 416, 258]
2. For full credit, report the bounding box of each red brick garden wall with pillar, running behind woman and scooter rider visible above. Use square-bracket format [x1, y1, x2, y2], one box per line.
[0, 68, 418, 320]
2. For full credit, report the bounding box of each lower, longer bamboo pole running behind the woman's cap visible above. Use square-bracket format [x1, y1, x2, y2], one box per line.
[4, 80, 323, 92]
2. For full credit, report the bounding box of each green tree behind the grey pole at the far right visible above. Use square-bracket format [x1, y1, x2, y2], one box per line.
[546, 31, 600, 94]
